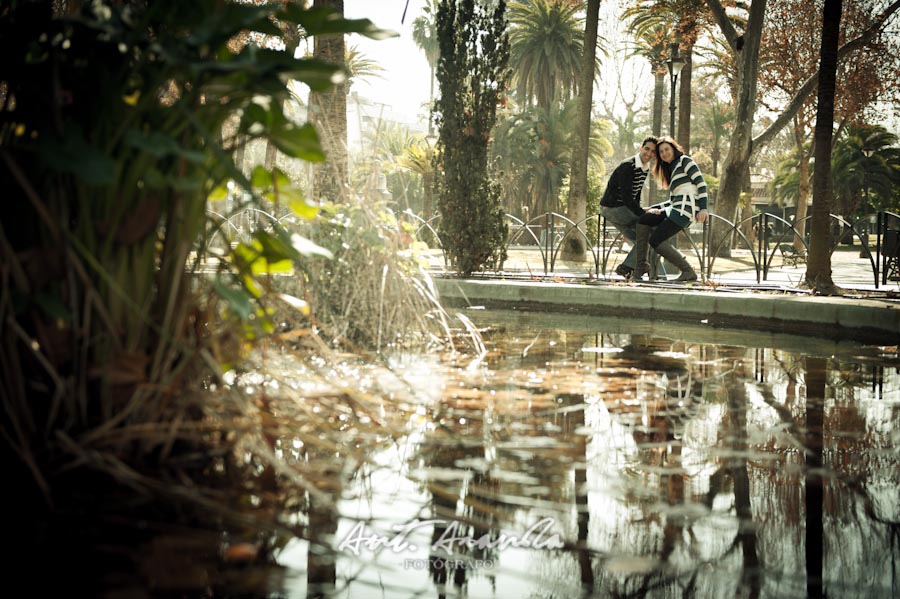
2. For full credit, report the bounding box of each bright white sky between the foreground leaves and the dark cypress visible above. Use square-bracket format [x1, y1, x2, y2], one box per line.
[344, 0, 430, 129]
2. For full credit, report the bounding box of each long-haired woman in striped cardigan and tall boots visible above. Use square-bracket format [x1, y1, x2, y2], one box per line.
[631, 136, 708, 281]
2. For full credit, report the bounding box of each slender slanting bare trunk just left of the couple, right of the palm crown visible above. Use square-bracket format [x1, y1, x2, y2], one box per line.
[562, 0, 600, 260]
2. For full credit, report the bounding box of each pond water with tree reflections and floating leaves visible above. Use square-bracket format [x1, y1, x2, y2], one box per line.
[278, 311, 900, 599]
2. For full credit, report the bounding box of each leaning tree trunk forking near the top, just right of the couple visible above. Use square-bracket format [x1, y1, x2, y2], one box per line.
[707, 0, 766, 256]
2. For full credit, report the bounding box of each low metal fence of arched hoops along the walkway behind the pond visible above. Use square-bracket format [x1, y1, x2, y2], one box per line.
[399, 211, 900, 289]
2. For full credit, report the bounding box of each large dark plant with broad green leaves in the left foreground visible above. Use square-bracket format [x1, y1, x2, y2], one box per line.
[0, 0, 386, 502]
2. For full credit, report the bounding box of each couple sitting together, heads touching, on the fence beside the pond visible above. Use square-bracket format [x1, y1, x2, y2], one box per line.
[600, 136, 708, 281]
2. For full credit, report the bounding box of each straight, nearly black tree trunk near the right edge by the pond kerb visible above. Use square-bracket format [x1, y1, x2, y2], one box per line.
[805, 0, 842, 293]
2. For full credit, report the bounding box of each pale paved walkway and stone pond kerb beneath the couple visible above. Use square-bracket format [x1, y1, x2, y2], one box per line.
[431, 248, 900, 345]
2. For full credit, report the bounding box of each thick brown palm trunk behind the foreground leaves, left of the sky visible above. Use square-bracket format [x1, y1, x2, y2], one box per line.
[309, 0, 348, 203]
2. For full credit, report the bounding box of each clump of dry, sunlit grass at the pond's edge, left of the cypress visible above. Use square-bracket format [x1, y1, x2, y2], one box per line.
[286, 202, 452, 352]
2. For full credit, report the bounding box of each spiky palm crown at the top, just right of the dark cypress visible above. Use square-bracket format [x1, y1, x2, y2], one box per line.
[508, 0, 584, 110]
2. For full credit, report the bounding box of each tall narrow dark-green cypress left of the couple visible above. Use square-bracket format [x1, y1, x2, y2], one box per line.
[435, 0, 509, 275]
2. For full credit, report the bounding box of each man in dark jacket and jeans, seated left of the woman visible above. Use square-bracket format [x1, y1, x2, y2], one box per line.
[600, 135, 668, 279]
